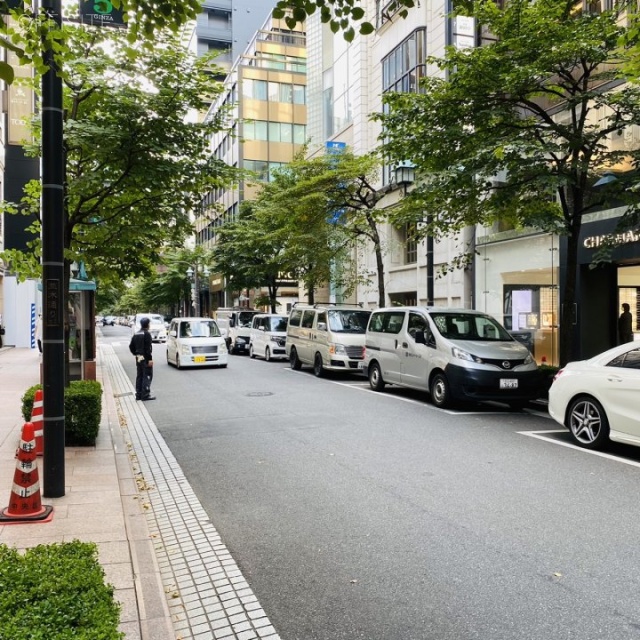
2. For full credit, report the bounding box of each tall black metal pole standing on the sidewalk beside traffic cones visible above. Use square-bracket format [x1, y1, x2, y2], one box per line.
[42, 0, 67, 498]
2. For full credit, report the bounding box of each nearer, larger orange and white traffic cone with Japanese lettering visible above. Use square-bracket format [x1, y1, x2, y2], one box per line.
[0, 422, 53, 525]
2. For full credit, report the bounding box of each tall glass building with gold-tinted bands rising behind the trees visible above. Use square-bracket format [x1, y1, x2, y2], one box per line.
[196, 17, 307, 311]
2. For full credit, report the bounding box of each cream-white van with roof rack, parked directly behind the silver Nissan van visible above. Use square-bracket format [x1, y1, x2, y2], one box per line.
[285, 303, 371, 377]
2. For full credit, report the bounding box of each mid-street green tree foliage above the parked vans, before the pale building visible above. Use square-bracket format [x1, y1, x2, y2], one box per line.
[214, 151, 385, 304]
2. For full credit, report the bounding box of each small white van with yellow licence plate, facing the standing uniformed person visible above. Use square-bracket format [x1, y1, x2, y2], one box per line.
[167, 318, 228, 369]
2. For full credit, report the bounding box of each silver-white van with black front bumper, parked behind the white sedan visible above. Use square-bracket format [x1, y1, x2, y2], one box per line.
[364, 307, 540, 409]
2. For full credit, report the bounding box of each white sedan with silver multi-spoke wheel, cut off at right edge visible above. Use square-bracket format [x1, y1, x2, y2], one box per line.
[549, 342, 640, 449]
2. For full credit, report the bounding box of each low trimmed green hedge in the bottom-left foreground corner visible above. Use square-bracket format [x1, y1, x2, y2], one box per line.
[0, 540, 124, 640]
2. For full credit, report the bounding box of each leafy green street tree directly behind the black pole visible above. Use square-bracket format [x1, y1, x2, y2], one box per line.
[5, 27, 233, 288]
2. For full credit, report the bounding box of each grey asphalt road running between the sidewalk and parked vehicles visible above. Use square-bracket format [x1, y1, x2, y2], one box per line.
[103, 327, 640, 640]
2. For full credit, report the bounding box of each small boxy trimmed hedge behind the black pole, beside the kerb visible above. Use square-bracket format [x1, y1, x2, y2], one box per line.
[22, 380, 102, 447]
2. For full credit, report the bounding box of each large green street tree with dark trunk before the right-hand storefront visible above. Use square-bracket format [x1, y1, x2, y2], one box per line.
[379, 0, 640, 363]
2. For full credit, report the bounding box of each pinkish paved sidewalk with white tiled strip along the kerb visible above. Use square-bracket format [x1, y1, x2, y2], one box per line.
[0, 337, 279, 640]
